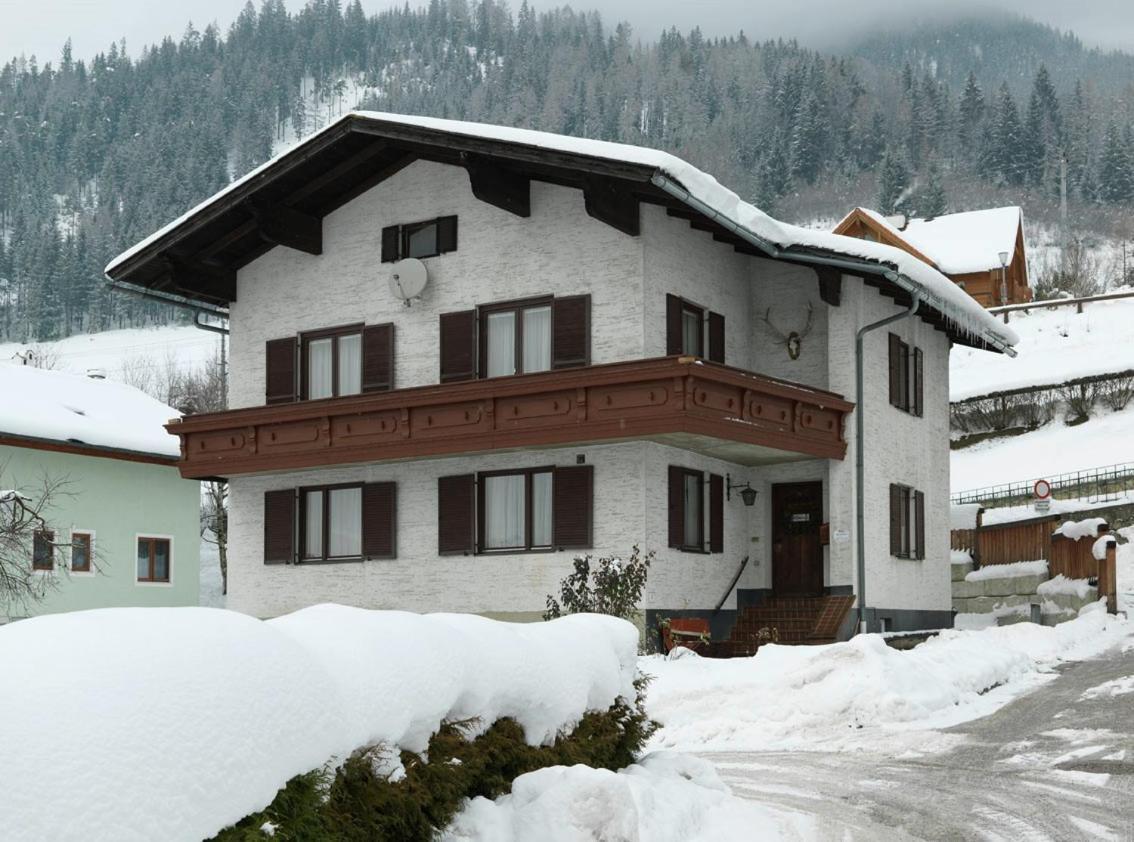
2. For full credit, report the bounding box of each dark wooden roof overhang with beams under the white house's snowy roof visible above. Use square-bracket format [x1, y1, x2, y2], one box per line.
[105, 113, 1007, 351]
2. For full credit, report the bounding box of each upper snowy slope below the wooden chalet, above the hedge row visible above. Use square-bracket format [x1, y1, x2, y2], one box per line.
[949, 289, 1134, 401]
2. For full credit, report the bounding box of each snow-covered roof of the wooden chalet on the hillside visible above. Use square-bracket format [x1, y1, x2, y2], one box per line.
[835, 206, 1024, 275]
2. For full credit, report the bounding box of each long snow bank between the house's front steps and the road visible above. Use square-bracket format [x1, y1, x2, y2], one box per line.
[641, 603, 1132, 751]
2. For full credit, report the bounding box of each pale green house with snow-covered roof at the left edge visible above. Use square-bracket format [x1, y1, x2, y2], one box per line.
[0, 364, 201, 622]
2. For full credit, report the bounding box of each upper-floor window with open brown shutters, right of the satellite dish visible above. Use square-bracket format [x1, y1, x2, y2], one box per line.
[439, 296, 591, 383]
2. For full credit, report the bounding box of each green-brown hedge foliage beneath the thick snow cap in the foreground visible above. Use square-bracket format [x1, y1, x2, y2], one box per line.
[214, 678, 657, 842]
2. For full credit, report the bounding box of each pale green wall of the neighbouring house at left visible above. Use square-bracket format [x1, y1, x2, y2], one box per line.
[0, 445, 201, 621]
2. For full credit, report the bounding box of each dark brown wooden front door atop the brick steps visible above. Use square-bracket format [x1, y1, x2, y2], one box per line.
[772, 483, 823, 596]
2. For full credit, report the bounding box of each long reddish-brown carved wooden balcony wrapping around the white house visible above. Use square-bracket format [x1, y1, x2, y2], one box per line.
[166, 357, 854, 478]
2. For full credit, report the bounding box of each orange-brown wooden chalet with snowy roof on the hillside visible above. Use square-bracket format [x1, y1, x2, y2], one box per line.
[835, 206, 1032, 307]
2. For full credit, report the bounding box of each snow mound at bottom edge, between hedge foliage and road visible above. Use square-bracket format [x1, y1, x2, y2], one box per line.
[441, 752, 815, 842]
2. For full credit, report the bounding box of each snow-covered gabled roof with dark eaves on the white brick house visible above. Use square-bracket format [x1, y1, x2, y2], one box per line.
[105, 111, 1016, 350]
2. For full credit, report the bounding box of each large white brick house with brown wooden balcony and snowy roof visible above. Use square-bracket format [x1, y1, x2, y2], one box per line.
[107, 112, 1016, 650]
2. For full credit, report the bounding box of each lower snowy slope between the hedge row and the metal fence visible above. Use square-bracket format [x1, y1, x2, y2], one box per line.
[949, 403, 1134, 491]
